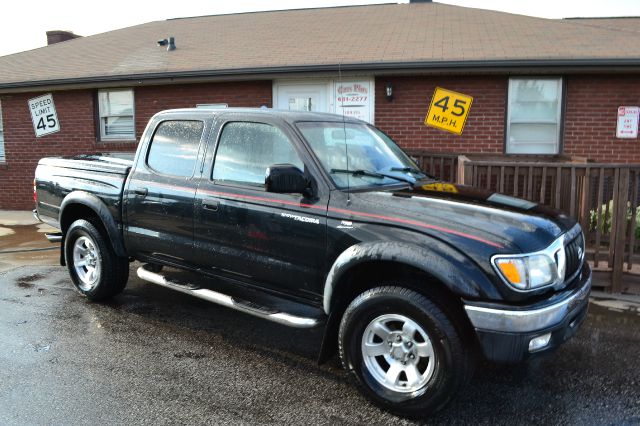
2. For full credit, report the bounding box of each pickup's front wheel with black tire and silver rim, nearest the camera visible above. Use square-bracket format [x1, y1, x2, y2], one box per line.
[338, 286, 472, 418]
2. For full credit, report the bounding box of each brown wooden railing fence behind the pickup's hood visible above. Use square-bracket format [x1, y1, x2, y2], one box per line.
[410, 153, 640, 293]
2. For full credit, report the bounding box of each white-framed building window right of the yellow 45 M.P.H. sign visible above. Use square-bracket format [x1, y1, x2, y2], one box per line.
[507, 78, 562, 154]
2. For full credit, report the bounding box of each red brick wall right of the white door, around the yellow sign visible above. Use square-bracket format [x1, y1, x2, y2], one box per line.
[376, 75, 640, 163]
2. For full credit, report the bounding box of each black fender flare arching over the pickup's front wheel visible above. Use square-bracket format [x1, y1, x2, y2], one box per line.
[323, 239, 499, 315]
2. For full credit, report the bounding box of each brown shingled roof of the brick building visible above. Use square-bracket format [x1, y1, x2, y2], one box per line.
[0, 3, 640, 91]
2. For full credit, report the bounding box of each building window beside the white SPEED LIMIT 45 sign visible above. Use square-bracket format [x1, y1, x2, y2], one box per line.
[98, 89, 136, 140]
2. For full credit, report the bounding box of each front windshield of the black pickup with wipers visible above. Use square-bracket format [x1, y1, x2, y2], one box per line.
[297, 121, 425, 189]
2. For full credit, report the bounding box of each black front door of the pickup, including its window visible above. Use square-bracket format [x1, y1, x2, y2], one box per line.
[195, 115, 329, 297]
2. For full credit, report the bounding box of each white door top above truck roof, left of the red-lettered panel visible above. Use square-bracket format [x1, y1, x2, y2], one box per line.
[273, 82, 330, 112]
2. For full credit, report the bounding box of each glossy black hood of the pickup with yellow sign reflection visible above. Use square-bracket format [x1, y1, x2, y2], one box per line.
[353, 182, 576, 253]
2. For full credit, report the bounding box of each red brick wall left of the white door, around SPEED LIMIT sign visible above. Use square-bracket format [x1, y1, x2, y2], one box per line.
[0, 81, 271, 209]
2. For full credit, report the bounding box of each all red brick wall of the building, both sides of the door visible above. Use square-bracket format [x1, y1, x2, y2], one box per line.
[0, 75, 640, 209]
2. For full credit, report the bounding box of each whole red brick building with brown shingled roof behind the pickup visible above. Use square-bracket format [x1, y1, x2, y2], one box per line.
[0, 1, 640, 209]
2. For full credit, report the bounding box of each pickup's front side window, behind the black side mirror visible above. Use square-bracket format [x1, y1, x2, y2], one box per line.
[212, 122, 304, 186]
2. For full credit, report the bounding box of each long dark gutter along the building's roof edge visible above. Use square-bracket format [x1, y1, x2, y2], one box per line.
[0, 58, 640, 93]
